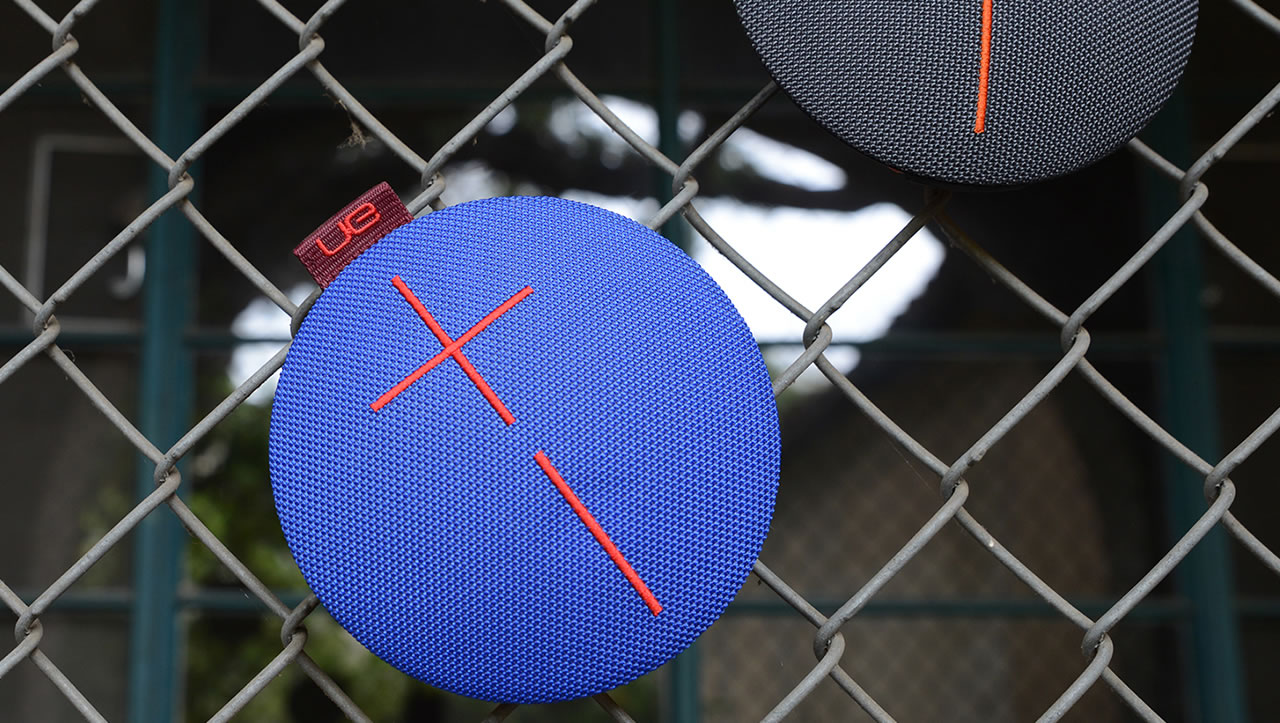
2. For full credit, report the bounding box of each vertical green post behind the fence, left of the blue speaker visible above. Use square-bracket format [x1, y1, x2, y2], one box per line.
[128, 0, 201, 723]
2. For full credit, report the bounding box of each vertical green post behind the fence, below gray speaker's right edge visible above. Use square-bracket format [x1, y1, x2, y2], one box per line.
[1146, 93, 1248, 723]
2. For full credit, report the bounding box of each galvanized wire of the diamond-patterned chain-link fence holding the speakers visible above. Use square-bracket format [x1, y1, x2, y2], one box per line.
[0, 0, 1280, 722]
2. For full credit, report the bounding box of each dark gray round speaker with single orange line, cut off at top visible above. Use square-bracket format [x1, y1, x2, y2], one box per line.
[735, 0, 1197, 187]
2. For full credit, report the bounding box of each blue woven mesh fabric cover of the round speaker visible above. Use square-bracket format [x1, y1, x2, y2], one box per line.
[270, 197, 780, 703]
